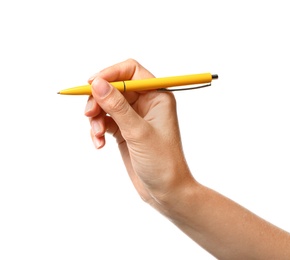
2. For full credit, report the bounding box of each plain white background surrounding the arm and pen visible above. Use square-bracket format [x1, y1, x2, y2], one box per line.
[0, 0, 290, 260]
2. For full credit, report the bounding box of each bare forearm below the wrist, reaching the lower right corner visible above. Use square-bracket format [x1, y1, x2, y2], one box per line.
[161, 180, 290, 259]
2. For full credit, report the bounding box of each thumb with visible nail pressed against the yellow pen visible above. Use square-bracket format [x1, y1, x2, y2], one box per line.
[92, 78, 144, 139]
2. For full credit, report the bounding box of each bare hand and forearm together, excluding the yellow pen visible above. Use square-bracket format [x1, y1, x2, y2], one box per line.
[85, 59, 290, 260]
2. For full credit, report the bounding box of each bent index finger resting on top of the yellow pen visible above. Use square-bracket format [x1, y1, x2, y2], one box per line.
[88, 59, 154, 84]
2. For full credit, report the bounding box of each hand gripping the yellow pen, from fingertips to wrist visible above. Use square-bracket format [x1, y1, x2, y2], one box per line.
[85, 59, 193, 211]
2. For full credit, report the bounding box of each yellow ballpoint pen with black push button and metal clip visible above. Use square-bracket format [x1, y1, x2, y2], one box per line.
[58, 73, 218, 95]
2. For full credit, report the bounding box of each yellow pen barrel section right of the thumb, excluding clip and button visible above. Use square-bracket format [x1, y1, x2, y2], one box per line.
[111, 73, 212, 92]
